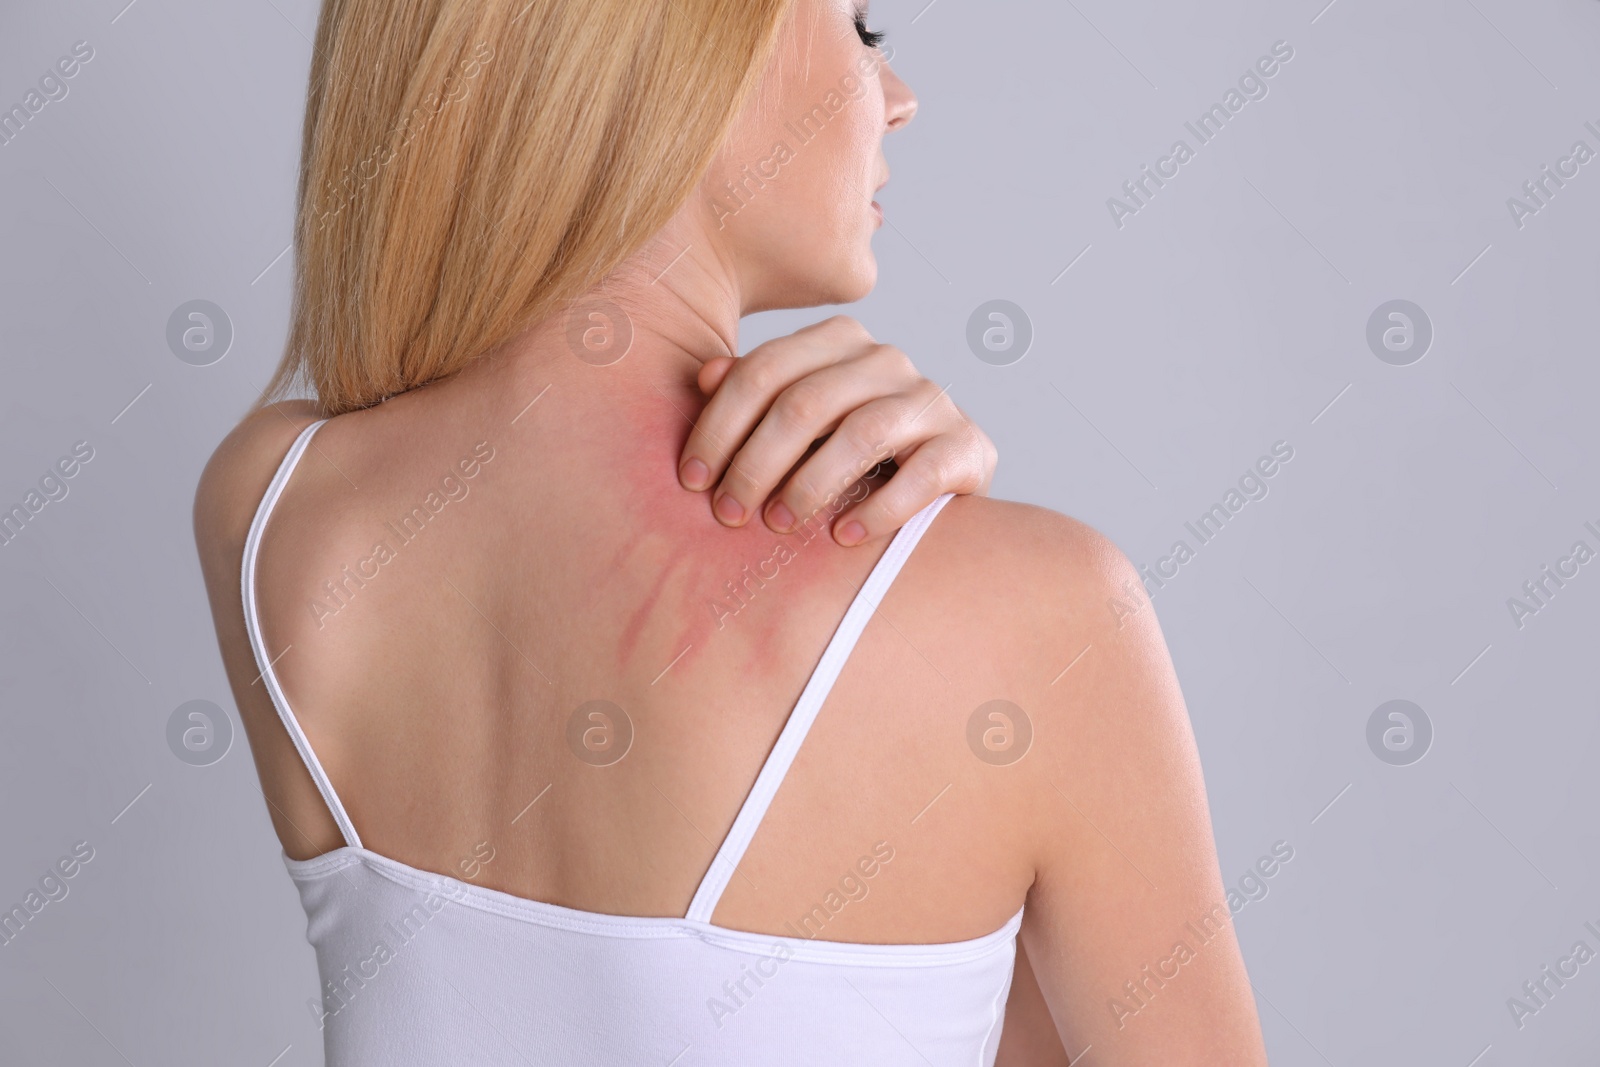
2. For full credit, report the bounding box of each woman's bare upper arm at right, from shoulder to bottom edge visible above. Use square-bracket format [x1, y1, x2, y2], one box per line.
[1021, 520, 1266, 1067]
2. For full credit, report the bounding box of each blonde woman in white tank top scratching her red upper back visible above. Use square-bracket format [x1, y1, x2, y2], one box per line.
[195, 0, 1266, 1065]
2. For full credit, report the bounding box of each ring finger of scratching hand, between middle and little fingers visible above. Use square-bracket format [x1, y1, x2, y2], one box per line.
[764, 379, 972, 533]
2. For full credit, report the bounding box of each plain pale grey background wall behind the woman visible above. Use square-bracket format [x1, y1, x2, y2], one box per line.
[0, 0, 1600, 1067]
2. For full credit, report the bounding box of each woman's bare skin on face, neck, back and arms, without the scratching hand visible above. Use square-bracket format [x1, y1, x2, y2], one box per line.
[195, 0, 1266, 1065]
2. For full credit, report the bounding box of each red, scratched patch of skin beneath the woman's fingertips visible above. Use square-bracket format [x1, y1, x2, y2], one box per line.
[464, 352, 883, 681]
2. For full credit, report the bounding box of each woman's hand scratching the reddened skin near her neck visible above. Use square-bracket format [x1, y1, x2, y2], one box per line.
[678, 315, 998, 545]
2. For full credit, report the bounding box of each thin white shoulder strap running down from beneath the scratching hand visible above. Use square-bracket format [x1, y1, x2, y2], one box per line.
[685, 493, 955, 923]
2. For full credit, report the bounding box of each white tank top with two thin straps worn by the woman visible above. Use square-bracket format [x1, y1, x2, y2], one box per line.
[243, 422, 1022, 1067]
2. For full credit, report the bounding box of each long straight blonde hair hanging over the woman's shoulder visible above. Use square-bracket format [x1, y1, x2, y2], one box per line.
[259, 0, 795, 416]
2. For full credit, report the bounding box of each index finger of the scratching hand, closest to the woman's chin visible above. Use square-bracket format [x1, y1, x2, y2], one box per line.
[678, 315, 872, 491]
